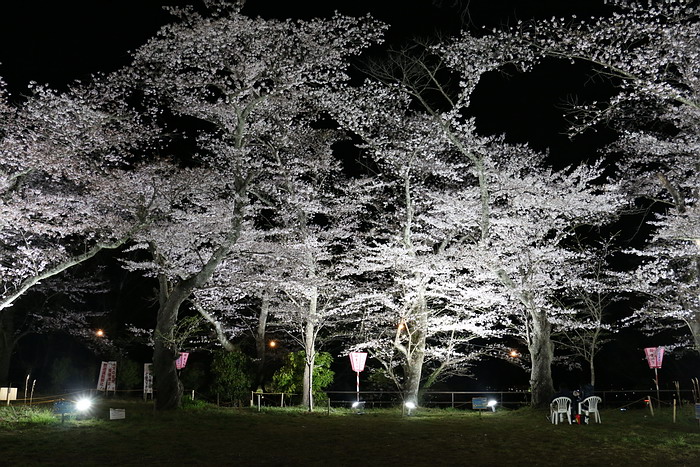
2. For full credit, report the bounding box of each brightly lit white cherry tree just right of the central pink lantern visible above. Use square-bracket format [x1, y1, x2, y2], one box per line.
[330, 77, 506, 401]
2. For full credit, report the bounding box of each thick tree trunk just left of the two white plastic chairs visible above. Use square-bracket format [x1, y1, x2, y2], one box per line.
[528, 310, 554, 407]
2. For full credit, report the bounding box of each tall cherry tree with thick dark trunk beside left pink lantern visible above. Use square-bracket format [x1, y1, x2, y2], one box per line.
[119, 2, 381, 409]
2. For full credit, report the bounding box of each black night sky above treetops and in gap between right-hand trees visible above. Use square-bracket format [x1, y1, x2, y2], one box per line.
[0, 0, 692, 394]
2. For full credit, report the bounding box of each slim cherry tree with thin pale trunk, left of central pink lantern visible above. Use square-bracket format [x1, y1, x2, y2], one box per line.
[262, 158, 357, 411]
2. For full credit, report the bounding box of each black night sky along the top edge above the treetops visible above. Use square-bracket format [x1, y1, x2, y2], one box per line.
[0, 0, 604, 90]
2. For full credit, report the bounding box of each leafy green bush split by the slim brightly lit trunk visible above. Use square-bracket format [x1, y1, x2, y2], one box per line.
[272, 350, 335, 401]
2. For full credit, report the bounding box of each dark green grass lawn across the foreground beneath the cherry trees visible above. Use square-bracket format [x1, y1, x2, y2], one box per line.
[0, 400, 700, 467]
